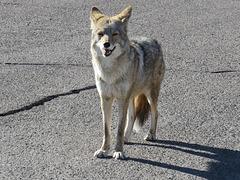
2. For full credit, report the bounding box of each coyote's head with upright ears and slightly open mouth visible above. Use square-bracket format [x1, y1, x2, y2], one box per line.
[91, 6, 132, 58]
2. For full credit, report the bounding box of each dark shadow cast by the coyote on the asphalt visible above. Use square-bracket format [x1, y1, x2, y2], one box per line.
[128, 140, 240, 180]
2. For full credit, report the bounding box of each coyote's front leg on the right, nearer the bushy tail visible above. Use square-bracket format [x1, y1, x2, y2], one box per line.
[113, 99, 129, 159]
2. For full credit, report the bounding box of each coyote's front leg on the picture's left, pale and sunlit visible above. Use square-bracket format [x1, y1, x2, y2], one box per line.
[94, 95, 113, 158]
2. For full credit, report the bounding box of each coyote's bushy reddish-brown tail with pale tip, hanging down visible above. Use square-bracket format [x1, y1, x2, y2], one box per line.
[133, 94, 151, 131]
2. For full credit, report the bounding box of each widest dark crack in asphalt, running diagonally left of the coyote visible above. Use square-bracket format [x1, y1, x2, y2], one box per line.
[0, 85, 96, 116]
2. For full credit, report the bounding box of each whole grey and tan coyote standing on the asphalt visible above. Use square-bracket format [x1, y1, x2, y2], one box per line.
[90, 6, 165, 159]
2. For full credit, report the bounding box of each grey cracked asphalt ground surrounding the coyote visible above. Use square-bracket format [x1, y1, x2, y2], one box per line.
[0, 0, 240, 180]
